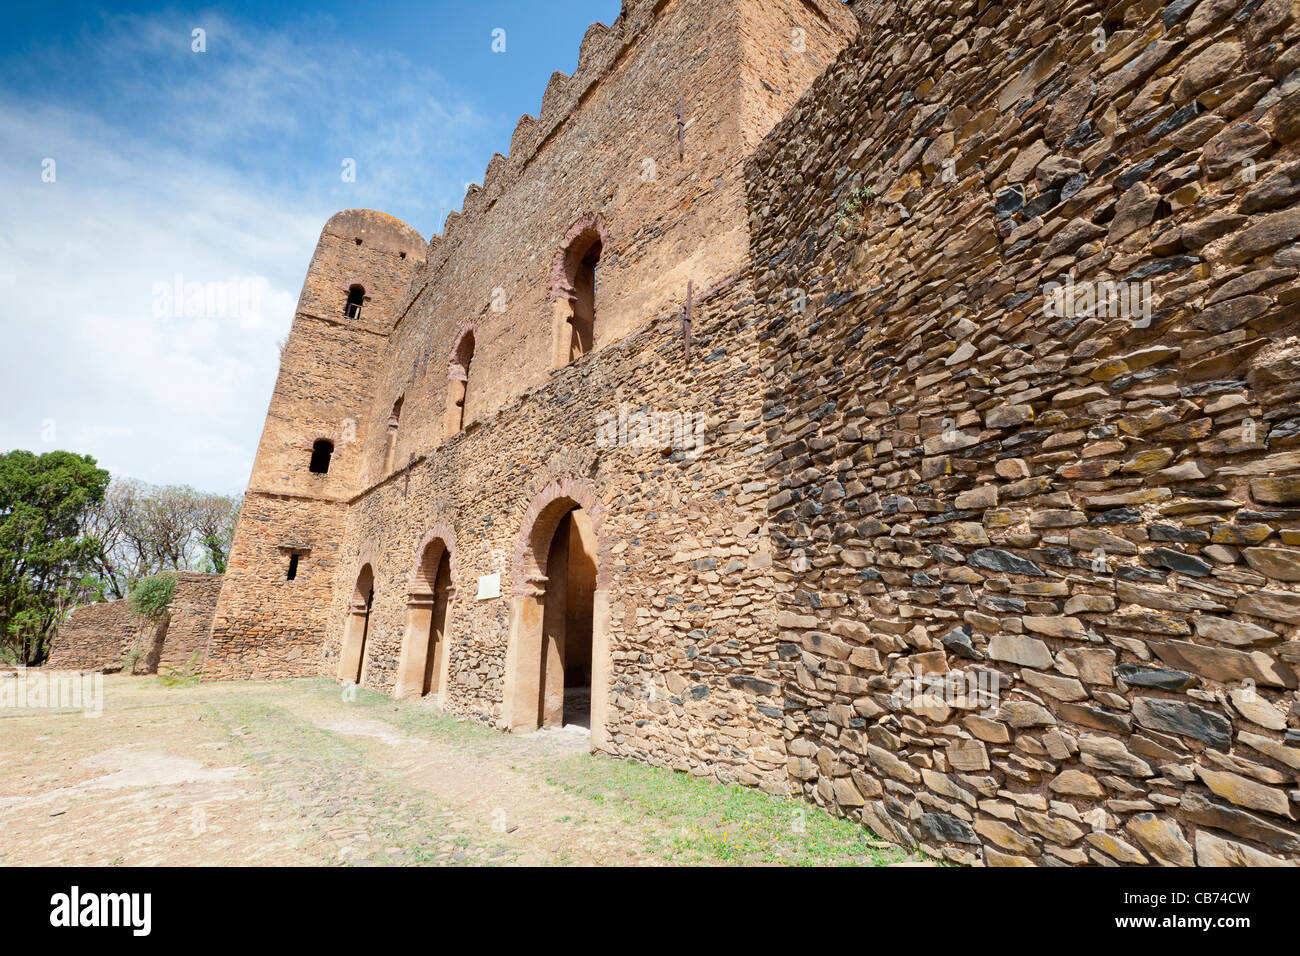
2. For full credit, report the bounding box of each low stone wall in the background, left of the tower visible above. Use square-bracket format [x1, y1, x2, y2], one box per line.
[46, 571, 221, 674]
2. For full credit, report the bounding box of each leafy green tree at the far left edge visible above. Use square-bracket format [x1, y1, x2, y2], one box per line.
[0, 450, 109, 666]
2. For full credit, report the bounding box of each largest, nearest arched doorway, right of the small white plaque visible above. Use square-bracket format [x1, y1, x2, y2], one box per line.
[502, 481, 610, 748]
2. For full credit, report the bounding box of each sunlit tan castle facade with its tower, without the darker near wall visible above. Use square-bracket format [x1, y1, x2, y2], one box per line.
[205, 0, 858, 792]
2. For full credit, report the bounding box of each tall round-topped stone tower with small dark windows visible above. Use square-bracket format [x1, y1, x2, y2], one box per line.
[205, 209, 425, 679]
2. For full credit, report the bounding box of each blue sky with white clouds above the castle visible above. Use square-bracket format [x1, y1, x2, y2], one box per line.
[0, 0, 619, 492]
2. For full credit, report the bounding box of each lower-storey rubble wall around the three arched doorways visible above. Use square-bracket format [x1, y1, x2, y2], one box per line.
[324, 273, 785, 790]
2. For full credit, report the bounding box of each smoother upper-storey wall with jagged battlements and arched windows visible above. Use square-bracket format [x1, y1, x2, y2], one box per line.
[356, 0, 855, 492]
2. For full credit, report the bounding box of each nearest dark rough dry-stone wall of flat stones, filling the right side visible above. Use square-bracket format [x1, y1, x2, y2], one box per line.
[749, 0, 1300, 866]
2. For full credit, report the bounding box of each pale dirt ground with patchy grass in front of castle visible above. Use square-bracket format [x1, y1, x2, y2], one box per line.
[0, 675, 915, 866]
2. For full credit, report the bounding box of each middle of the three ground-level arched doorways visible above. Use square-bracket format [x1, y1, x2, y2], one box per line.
[394, 532, 455, 697]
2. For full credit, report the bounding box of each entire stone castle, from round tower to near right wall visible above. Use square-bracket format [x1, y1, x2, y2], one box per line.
[205, 0, 1300, 865]
